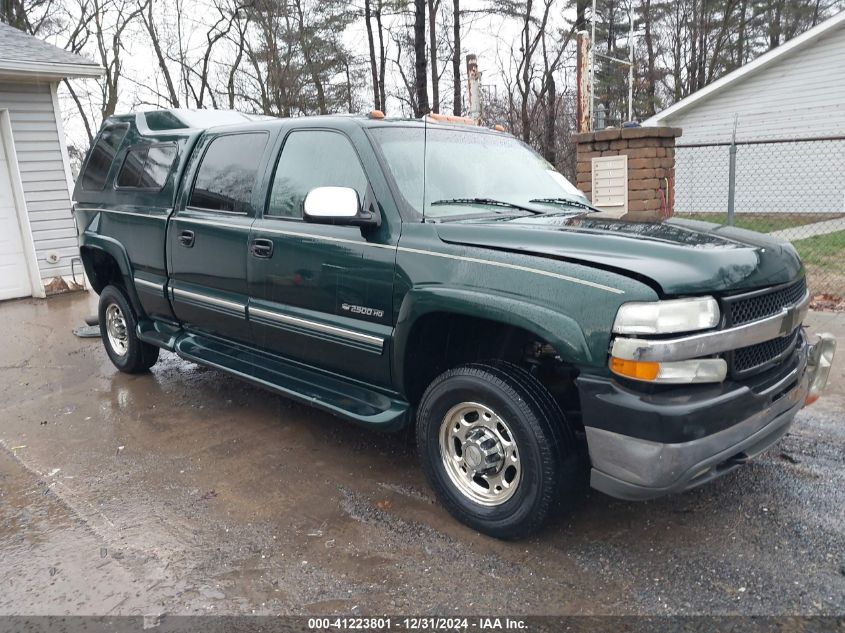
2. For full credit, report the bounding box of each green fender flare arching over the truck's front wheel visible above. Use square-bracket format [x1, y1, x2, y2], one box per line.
[391, 286, 593, 389]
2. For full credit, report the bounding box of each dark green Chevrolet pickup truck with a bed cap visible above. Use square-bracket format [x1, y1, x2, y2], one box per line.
[74, 110, 835, 538]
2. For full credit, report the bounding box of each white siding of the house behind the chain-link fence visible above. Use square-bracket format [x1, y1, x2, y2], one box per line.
[661, 26, 845, 213]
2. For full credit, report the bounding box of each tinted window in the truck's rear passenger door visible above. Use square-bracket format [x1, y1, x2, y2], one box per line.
[188, 132, 267, 213]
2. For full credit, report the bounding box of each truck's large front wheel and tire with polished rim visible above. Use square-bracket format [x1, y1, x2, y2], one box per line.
[417, 361, 583, 540]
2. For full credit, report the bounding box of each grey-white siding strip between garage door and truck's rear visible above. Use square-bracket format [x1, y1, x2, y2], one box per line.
[0, 79, 79, 281]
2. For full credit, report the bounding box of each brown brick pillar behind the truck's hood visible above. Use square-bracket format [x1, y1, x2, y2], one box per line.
[573, 127, 681, 222]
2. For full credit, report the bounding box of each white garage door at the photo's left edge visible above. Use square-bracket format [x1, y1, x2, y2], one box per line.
[0, 134, 32, 299]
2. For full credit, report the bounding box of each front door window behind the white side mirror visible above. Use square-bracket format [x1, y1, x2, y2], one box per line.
[267, 130, 367, 218]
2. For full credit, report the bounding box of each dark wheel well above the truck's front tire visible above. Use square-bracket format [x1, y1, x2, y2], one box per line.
[403, 312, 581, 428]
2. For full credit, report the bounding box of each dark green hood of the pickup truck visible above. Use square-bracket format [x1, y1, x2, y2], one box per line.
[437, 215, 802, 296]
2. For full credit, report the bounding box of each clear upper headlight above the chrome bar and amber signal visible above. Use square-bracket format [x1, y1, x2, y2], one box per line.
[613, 297, 720, 334]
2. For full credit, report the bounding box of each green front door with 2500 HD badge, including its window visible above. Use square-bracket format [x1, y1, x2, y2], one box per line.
[248, 128, 396, 386]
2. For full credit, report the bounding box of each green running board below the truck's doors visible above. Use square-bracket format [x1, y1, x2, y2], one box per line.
[173, 333, 410, 431]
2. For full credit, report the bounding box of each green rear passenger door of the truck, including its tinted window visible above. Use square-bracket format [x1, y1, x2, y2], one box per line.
[167, 130, 270, 343]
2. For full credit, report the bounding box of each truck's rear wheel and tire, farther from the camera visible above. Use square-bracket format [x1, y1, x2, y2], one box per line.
[97, 286, 158, 374]
